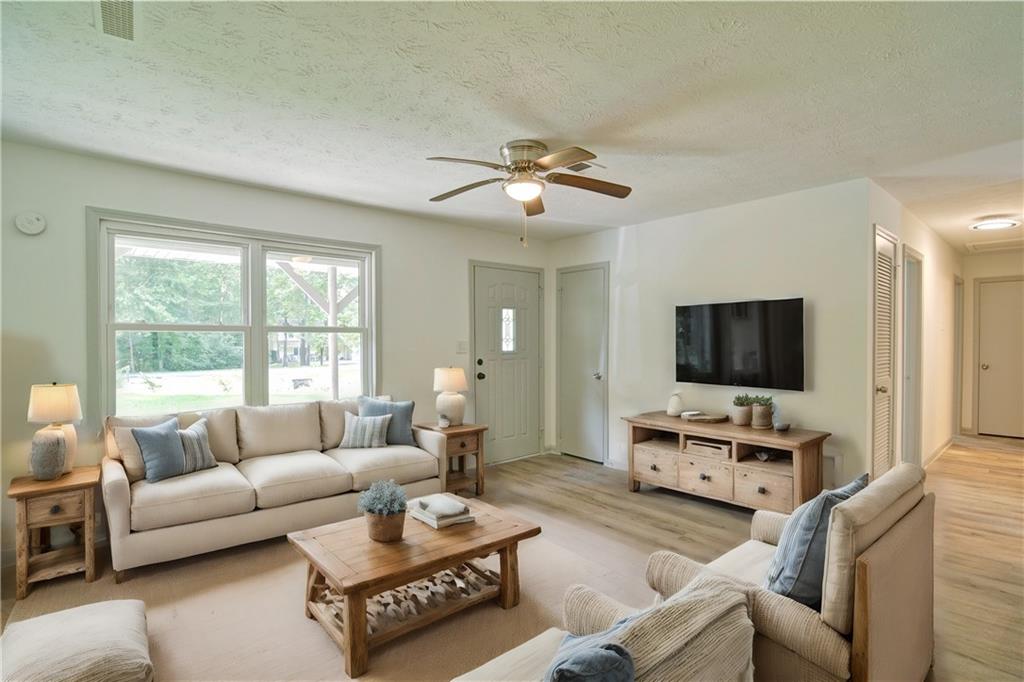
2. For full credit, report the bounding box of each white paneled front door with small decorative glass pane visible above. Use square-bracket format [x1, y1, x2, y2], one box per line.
[473, 265, 541, 462]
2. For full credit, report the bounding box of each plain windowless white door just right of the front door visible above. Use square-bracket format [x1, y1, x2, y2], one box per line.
[557, 265, 608, 463]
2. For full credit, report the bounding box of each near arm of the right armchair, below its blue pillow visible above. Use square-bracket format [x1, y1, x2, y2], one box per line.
[751, 587, 850, 680]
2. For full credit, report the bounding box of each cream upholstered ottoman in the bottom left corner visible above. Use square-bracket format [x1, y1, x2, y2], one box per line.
[0, 599, 153, 682]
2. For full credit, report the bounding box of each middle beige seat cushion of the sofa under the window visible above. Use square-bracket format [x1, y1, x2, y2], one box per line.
[239, 448, 352, 509]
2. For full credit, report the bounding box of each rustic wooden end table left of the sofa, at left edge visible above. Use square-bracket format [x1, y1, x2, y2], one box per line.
[7, 466, 99, 599]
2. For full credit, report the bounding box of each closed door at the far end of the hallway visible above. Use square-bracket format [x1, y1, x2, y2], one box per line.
[977, 280, 1024, 438]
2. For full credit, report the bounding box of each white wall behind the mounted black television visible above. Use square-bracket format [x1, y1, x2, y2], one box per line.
[546, 179, 871, 482]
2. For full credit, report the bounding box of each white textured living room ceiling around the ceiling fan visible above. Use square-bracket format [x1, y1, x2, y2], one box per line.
[2, 2, 1022, 237]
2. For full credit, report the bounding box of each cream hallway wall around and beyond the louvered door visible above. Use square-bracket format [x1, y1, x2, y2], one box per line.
[869, 182, 963, 464]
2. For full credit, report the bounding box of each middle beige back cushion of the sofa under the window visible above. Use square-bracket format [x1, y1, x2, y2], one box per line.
[236, 402, 321, 460]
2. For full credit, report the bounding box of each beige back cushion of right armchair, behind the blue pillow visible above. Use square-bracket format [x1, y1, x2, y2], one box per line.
[821, 463, 925, 635]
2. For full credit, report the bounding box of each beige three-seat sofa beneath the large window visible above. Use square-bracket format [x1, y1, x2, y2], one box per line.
[102, 400, 445, 580]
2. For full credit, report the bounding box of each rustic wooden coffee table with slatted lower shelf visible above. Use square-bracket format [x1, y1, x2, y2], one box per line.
[288, 493, 541, 677]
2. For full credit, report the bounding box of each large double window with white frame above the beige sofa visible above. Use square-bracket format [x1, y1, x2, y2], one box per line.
[99, 215, 377, 415]
